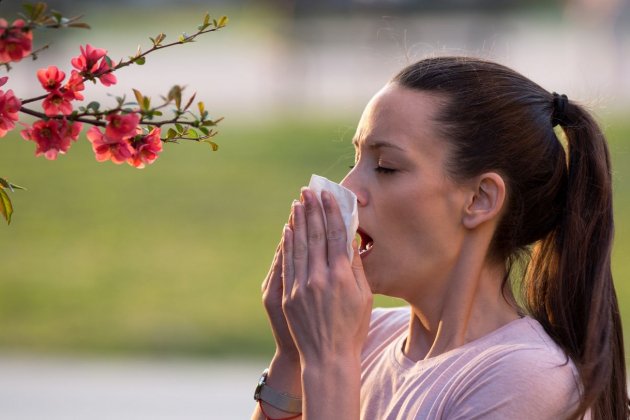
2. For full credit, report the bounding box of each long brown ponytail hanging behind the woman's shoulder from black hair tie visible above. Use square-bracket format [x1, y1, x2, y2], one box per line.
[524, 103, 629, 420]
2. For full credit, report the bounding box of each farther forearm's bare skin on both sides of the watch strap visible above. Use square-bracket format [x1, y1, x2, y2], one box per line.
[252, 353, 302, 420]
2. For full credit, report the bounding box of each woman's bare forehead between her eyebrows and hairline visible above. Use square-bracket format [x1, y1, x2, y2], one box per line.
[353, 83, 444, 150]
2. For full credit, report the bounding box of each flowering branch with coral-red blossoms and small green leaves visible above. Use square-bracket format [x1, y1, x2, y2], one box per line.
[0, 2, 228, 222]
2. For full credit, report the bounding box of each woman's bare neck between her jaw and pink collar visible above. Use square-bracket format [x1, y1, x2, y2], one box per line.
[404, 241, 519, 360]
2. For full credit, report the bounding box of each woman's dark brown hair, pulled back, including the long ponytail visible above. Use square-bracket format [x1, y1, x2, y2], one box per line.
[392, 57, 629, 419]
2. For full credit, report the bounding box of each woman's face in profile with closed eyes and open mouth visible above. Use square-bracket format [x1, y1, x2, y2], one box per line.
[342, 84, 466, 300]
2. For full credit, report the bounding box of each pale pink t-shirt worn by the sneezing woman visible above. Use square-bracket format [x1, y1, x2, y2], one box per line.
[361, 307, 580, 420]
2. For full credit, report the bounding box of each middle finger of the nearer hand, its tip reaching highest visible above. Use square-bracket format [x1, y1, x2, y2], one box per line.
[302, 188, 327, 272]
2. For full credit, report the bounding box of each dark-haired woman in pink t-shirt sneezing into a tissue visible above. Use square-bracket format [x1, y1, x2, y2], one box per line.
[253, 57, 628, 420]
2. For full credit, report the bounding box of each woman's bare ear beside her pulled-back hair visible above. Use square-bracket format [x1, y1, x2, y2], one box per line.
[463, 172, 505, 229]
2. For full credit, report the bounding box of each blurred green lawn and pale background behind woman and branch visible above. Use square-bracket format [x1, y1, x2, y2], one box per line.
[0, 0, 630, 419]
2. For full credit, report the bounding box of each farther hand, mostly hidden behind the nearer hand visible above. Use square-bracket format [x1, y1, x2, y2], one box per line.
[261, 206, 299, 363]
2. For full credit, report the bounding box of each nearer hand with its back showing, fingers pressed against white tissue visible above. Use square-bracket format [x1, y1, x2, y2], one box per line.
[281, 189, 372, 363]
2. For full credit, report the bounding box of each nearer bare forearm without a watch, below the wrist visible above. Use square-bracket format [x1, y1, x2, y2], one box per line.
[302, 356, 361, 420]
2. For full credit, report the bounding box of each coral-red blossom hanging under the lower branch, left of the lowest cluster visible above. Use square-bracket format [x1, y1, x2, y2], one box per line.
[21, 119, 83, 160]
